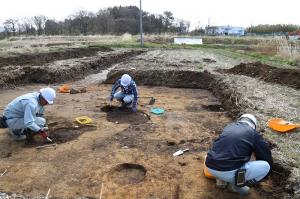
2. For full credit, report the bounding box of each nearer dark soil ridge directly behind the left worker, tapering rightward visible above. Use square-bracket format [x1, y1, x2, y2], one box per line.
[0, 50, 144, 88]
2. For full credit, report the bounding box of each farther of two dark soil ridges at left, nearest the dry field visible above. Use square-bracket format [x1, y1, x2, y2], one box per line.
[0, 47, 113, 68]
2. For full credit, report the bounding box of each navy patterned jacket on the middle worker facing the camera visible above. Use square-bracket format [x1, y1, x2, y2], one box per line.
[110, 79, 138, 108]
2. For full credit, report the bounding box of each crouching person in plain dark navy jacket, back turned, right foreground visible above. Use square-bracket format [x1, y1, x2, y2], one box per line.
[205, 114, 273, 195]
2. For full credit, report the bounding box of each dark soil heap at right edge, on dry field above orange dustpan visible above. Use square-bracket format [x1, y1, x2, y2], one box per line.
[223, 62, 300, 89]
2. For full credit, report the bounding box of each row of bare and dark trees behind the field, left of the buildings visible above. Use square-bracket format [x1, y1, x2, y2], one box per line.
[2, 6, 190, 37]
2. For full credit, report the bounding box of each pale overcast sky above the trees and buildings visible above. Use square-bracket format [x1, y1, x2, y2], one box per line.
[0, 0, 300, 27]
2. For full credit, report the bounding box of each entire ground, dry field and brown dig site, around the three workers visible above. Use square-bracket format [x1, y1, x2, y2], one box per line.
[0, 34, 300, 199]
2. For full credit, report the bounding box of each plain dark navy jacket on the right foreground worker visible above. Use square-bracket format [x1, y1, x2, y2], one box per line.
[205, 122, 273, 171]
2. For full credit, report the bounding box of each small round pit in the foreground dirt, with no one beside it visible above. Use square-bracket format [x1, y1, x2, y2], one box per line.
[109, 163, 147, 185]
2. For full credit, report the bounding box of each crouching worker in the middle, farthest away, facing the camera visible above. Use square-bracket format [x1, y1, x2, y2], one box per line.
[110, 74, 138, 112]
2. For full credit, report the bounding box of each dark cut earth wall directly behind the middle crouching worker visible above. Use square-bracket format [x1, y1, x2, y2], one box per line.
[105, 69, 213, 89]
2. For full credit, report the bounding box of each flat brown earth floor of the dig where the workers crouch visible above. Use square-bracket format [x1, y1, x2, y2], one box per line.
[0, 85, 284, 198]
